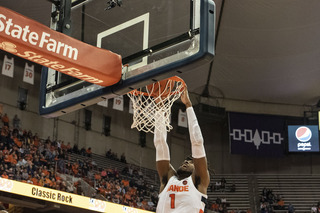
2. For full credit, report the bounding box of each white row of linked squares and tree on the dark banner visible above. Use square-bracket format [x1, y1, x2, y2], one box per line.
[230, 129, 284, 150]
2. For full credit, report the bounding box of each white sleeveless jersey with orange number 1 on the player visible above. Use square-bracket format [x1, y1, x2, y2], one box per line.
[157, 176, 208, 213]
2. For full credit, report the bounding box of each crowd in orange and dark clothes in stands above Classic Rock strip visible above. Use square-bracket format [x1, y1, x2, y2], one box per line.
[0, 114, 158, 211]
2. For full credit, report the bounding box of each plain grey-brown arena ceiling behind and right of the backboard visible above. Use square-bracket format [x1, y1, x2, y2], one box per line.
[0, 0, 320, 106]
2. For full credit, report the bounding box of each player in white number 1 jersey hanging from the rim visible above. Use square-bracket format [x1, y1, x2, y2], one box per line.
[154, 89, 210, 213]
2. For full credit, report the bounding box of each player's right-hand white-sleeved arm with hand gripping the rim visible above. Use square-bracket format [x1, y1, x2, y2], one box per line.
[181, 89, 210, 194]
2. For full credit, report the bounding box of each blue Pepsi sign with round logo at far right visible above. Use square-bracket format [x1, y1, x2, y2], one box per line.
[288, 125, 319, 152]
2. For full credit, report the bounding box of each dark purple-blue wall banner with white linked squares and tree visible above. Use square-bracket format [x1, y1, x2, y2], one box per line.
[229, 112, 286, 157]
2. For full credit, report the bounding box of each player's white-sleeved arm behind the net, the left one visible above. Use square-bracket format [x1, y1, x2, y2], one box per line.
[153, 112, 176, 192]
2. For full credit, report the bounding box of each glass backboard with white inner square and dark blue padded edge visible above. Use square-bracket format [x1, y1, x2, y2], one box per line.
[40, 0, 215, 117]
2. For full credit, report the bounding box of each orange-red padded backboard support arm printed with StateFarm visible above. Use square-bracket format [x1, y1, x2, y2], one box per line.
[0, 7, 122, 86]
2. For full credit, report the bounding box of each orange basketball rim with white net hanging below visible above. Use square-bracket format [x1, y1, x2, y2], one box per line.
[127, 76, 185, 133]
